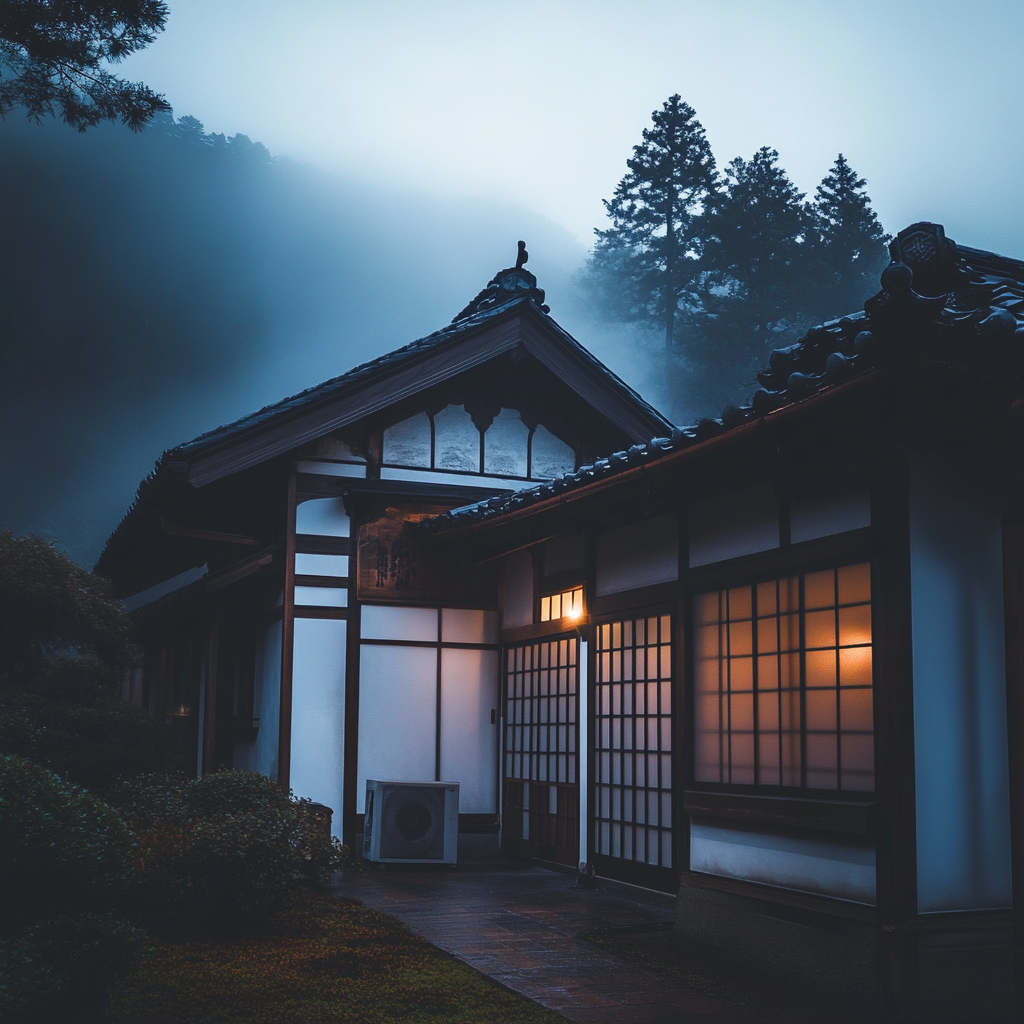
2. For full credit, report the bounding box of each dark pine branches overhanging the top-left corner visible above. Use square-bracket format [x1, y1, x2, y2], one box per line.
[0, 0, 170, 131]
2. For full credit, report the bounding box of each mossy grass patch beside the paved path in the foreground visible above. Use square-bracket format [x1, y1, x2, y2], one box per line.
[100, 891, 565, 1024]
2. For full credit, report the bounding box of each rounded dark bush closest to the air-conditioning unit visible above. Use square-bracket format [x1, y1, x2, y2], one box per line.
[124, 770, 342, 925]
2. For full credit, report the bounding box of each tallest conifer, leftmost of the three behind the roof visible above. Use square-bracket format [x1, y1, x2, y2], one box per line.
[588, 94, 717, 349]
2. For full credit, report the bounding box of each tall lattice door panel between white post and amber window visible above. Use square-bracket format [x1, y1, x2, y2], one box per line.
[594, 615, 673, 867]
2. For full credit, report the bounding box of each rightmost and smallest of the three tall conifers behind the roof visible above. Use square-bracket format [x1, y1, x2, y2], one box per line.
[808, 153, 889, 321]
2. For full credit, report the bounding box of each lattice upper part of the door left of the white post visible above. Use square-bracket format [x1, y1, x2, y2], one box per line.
[505, 639, 578, 784]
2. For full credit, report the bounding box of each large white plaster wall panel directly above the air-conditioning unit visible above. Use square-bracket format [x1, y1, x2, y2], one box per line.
[356, 647, 437, 814]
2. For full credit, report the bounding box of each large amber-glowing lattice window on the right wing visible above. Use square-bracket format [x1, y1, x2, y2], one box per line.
[694, 562, 874, 792]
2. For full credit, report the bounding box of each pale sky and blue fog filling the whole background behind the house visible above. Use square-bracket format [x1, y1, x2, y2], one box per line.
[0, 0, 1024, 565]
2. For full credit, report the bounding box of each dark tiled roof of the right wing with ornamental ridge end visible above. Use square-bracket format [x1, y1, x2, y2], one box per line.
[424, 223, 1024, 532]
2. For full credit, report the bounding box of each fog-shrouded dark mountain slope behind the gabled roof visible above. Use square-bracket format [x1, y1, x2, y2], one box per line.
[0, 117, 585, 564]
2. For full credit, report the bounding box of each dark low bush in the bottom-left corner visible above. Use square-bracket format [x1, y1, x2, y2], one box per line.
[0, 913, 145, 1024]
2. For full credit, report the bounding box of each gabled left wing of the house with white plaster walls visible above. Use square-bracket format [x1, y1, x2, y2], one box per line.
[97, 253, 672, 859]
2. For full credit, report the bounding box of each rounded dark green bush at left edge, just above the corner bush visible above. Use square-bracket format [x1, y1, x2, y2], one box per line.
[0, 756, 134, 935]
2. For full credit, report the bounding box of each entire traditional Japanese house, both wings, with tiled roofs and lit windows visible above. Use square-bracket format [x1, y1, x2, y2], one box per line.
[98, 223, 1024, 1019]
